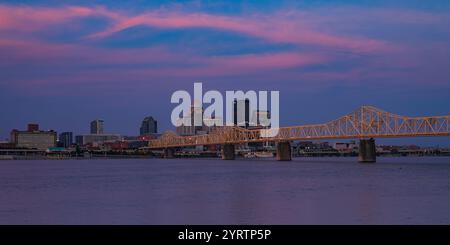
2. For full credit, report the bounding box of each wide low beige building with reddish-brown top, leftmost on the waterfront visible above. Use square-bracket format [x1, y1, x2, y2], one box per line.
[10, 124, 56, 150]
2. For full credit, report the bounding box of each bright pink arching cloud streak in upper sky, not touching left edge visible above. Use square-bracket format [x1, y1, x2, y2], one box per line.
[91, 11, 390, 52]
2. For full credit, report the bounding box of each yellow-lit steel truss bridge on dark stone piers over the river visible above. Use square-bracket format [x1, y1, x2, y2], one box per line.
[148, 106, 450, 162]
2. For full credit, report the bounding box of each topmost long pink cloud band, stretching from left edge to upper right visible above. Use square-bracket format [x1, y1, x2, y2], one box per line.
[0, 5, 390, 52]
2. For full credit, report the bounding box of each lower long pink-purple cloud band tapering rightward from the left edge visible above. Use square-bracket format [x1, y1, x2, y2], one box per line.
[0, 36, 330, 88]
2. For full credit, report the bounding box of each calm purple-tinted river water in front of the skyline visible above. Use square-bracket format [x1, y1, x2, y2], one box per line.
[0, 157, 450, 224]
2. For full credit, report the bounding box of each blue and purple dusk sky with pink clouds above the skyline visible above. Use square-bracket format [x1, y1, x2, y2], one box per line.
[0, 0, 450, 146]
